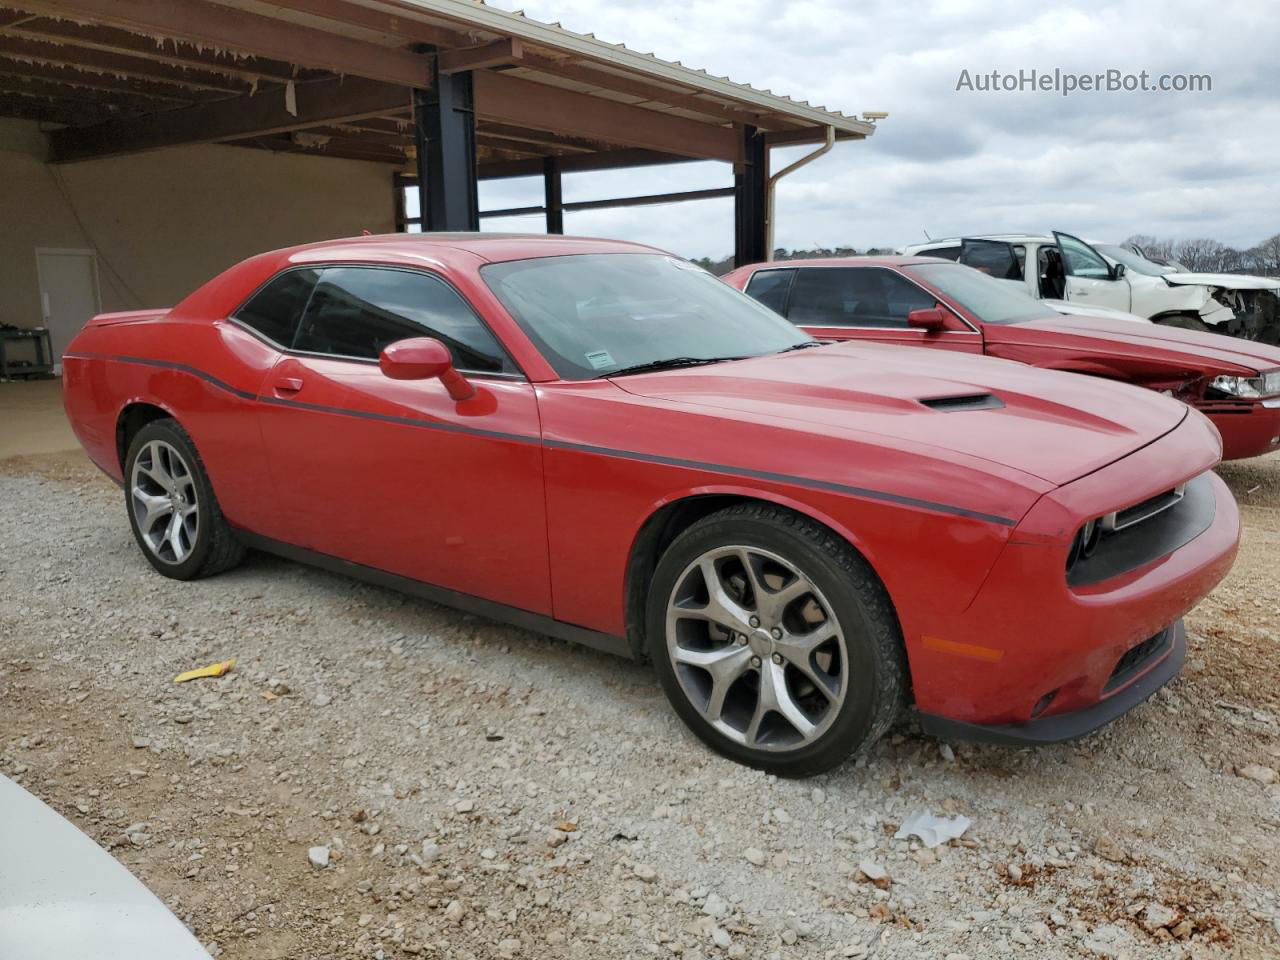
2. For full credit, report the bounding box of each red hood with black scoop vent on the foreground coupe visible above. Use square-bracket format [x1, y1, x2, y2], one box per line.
[613, 342, 1187, 484]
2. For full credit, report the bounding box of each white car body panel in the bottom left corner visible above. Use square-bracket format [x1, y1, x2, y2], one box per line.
[0, 777, 209, 960]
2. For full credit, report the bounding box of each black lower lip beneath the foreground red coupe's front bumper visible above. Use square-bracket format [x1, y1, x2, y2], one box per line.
[920, 620, 1187, 746]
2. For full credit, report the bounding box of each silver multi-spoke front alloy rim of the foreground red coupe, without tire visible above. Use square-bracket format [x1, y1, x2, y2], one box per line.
[666, 545, 849, 751]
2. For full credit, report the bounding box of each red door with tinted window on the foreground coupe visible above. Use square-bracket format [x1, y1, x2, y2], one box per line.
[253, 265, 550, 614]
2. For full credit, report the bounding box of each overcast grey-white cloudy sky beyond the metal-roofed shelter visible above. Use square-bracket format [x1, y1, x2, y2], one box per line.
[481, 0, 1280, 257]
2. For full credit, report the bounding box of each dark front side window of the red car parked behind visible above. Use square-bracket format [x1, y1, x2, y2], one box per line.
[788, 266, 937, 328]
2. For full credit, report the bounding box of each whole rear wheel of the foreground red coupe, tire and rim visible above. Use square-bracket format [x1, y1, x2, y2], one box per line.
[124, 417, 244, 580]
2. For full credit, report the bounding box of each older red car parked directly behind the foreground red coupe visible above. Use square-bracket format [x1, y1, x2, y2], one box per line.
[724, 257, 1280, 460]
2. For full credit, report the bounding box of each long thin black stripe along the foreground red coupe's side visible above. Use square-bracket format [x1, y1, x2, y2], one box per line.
[65, 353, 1018, 526]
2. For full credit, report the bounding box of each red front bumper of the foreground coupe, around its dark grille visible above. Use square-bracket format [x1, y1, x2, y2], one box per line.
[901, 413, 1240, 732]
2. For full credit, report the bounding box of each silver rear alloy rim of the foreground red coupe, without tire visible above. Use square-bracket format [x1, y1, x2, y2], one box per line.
[129, 440, 200, 564]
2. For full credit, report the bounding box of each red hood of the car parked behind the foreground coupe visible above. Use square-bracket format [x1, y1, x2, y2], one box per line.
[984, 316, 1280, 372]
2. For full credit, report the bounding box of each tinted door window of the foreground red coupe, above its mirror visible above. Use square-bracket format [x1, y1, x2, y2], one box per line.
[293, 266, 516, 374]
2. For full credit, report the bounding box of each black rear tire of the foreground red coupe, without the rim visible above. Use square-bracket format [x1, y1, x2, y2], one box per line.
[124, 417, 246, 580]
